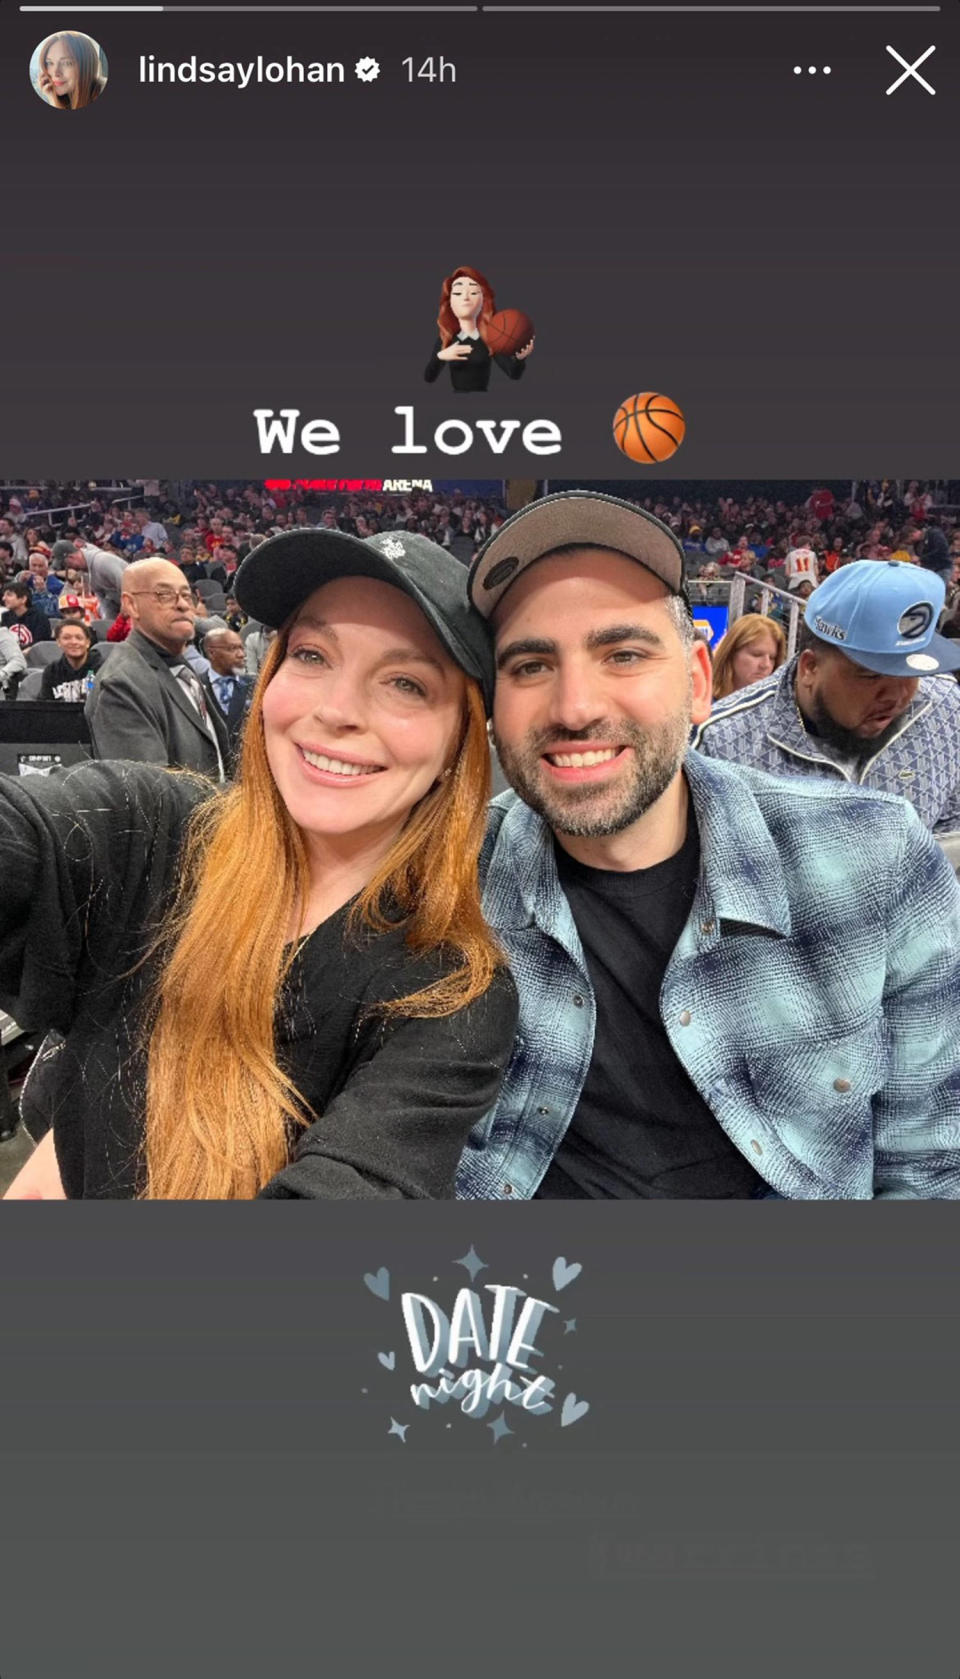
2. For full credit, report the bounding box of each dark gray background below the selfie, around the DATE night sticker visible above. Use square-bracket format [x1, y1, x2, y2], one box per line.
[0, 1202, 960, 1679]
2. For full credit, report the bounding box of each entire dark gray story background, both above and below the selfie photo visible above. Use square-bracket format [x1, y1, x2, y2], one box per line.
[0, 5, 960, 1679]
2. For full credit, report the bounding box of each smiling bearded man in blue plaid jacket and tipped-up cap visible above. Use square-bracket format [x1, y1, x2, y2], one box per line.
[458, 490, 960, 1200]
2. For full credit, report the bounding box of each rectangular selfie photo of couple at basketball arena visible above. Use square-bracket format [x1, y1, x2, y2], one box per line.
[0, 480, 960, 1200]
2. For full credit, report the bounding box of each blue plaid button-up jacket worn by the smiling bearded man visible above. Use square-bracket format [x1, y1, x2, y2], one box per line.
[457, 752, 960, 1200]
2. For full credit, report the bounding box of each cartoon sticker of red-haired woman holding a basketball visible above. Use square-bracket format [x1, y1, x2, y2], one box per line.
[423, 269, 534, 391]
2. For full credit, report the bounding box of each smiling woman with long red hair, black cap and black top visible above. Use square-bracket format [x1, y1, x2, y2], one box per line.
[0, 531, 515, 1200]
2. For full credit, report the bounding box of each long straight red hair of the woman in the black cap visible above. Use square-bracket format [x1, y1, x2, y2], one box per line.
[144, 635, 503, 1200]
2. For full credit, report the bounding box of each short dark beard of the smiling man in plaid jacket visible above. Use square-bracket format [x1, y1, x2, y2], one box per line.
[493, 705, 690, 840]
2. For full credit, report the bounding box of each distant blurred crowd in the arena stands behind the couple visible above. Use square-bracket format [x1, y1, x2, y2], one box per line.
[0, 480, 960, 687]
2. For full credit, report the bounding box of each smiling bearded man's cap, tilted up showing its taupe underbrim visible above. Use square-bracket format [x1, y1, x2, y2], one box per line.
[467, 490, 690, 618]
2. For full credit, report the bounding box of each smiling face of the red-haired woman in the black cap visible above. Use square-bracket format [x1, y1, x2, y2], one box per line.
[263, 578, 465, 850]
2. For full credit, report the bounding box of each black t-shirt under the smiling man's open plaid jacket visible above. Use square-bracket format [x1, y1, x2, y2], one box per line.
[537, 813, 760, 1200]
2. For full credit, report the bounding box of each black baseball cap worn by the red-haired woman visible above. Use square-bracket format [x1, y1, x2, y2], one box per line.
[233, 526, 493, 714]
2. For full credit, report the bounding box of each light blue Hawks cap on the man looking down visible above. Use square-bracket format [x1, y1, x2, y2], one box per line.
[804, 559, 960, 677]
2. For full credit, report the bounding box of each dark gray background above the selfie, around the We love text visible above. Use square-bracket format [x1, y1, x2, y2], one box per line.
[0, 0, 960, 479]
